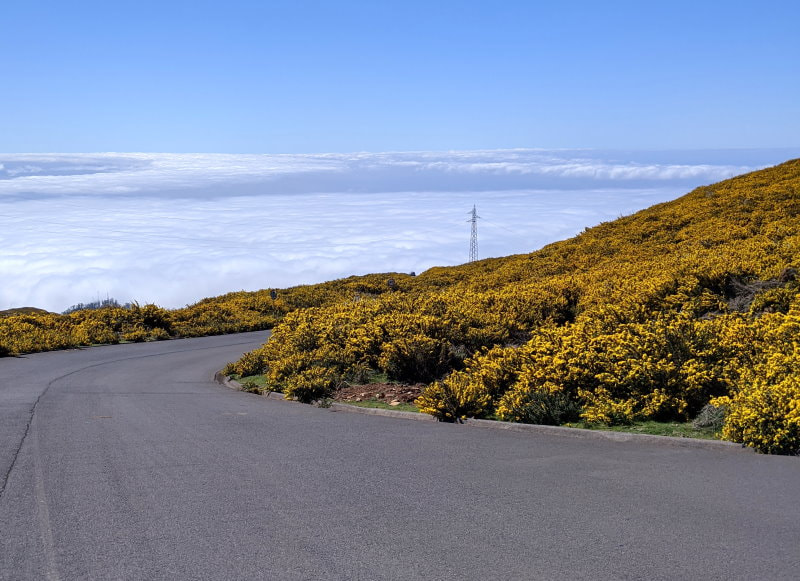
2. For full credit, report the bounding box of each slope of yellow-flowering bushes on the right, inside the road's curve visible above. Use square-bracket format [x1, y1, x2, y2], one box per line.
[229, 160, 800, 453]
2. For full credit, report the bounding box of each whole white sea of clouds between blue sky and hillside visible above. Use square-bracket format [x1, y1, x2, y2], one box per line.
[0, 150, 800, 311]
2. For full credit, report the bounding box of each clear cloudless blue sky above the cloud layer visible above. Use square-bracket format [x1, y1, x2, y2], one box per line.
[0, 0, 800, 153]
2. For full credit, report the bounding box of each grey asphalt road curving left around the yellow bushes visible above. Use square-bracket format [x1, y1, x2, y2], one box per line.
[0, 333, 800, 580]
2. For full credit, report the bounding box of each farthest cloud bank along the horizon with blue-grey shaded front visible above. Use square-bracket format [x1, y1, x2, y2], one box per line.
[0, 150, 764, 198]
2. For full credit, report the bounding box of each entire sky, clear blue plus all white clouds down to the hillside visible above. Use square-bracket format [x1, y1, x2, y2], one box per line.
[0, 0, 800, 310]
